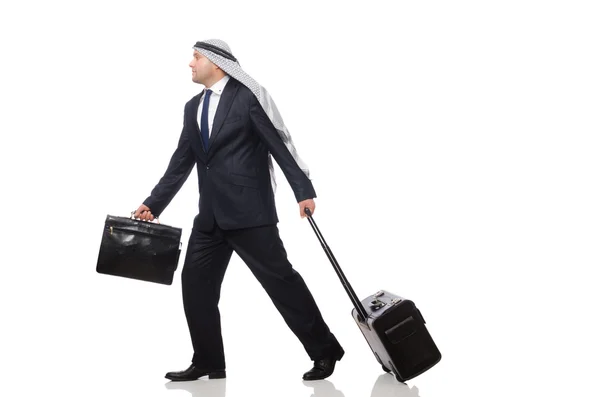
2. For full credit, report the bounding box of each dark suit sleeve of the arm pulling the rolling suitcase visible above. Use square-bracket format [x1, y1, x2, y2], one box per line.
[250, 95, 317, 202]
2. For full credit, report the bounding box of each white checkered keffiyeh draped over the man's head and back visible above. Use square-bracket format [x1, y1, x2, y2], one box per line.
[193, 39, 310, 192]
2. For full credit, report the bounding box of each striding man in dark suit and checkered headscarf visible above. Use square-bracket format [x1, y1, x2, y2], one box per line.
[135, 40, 344, 381]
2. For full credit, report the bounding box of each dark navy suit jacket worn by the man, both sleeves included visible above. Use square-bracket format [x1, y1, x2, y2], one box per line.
[144, 78, 316, 231]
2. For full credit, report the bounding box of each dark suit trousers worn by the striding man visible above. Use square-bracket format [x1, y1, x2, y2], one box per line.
[181, 222, 344, 370]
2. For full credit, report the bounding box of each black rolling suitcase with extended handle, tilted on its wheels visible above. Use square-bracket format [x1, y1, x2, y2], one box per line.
[305, 209, 442, 382]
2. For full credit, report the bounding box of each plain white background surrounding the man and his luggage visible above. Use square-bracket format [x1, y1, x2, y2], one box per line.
[0, 0, 600, 397]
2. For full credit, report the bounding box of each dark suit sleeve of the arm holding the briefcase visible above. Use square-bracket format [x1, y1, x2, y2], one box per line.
[144, 118, 196, 217]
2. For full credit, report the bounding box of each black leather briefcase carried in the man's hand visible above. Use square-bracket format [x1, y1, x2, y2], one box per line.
[96, 215, 181, 285]
